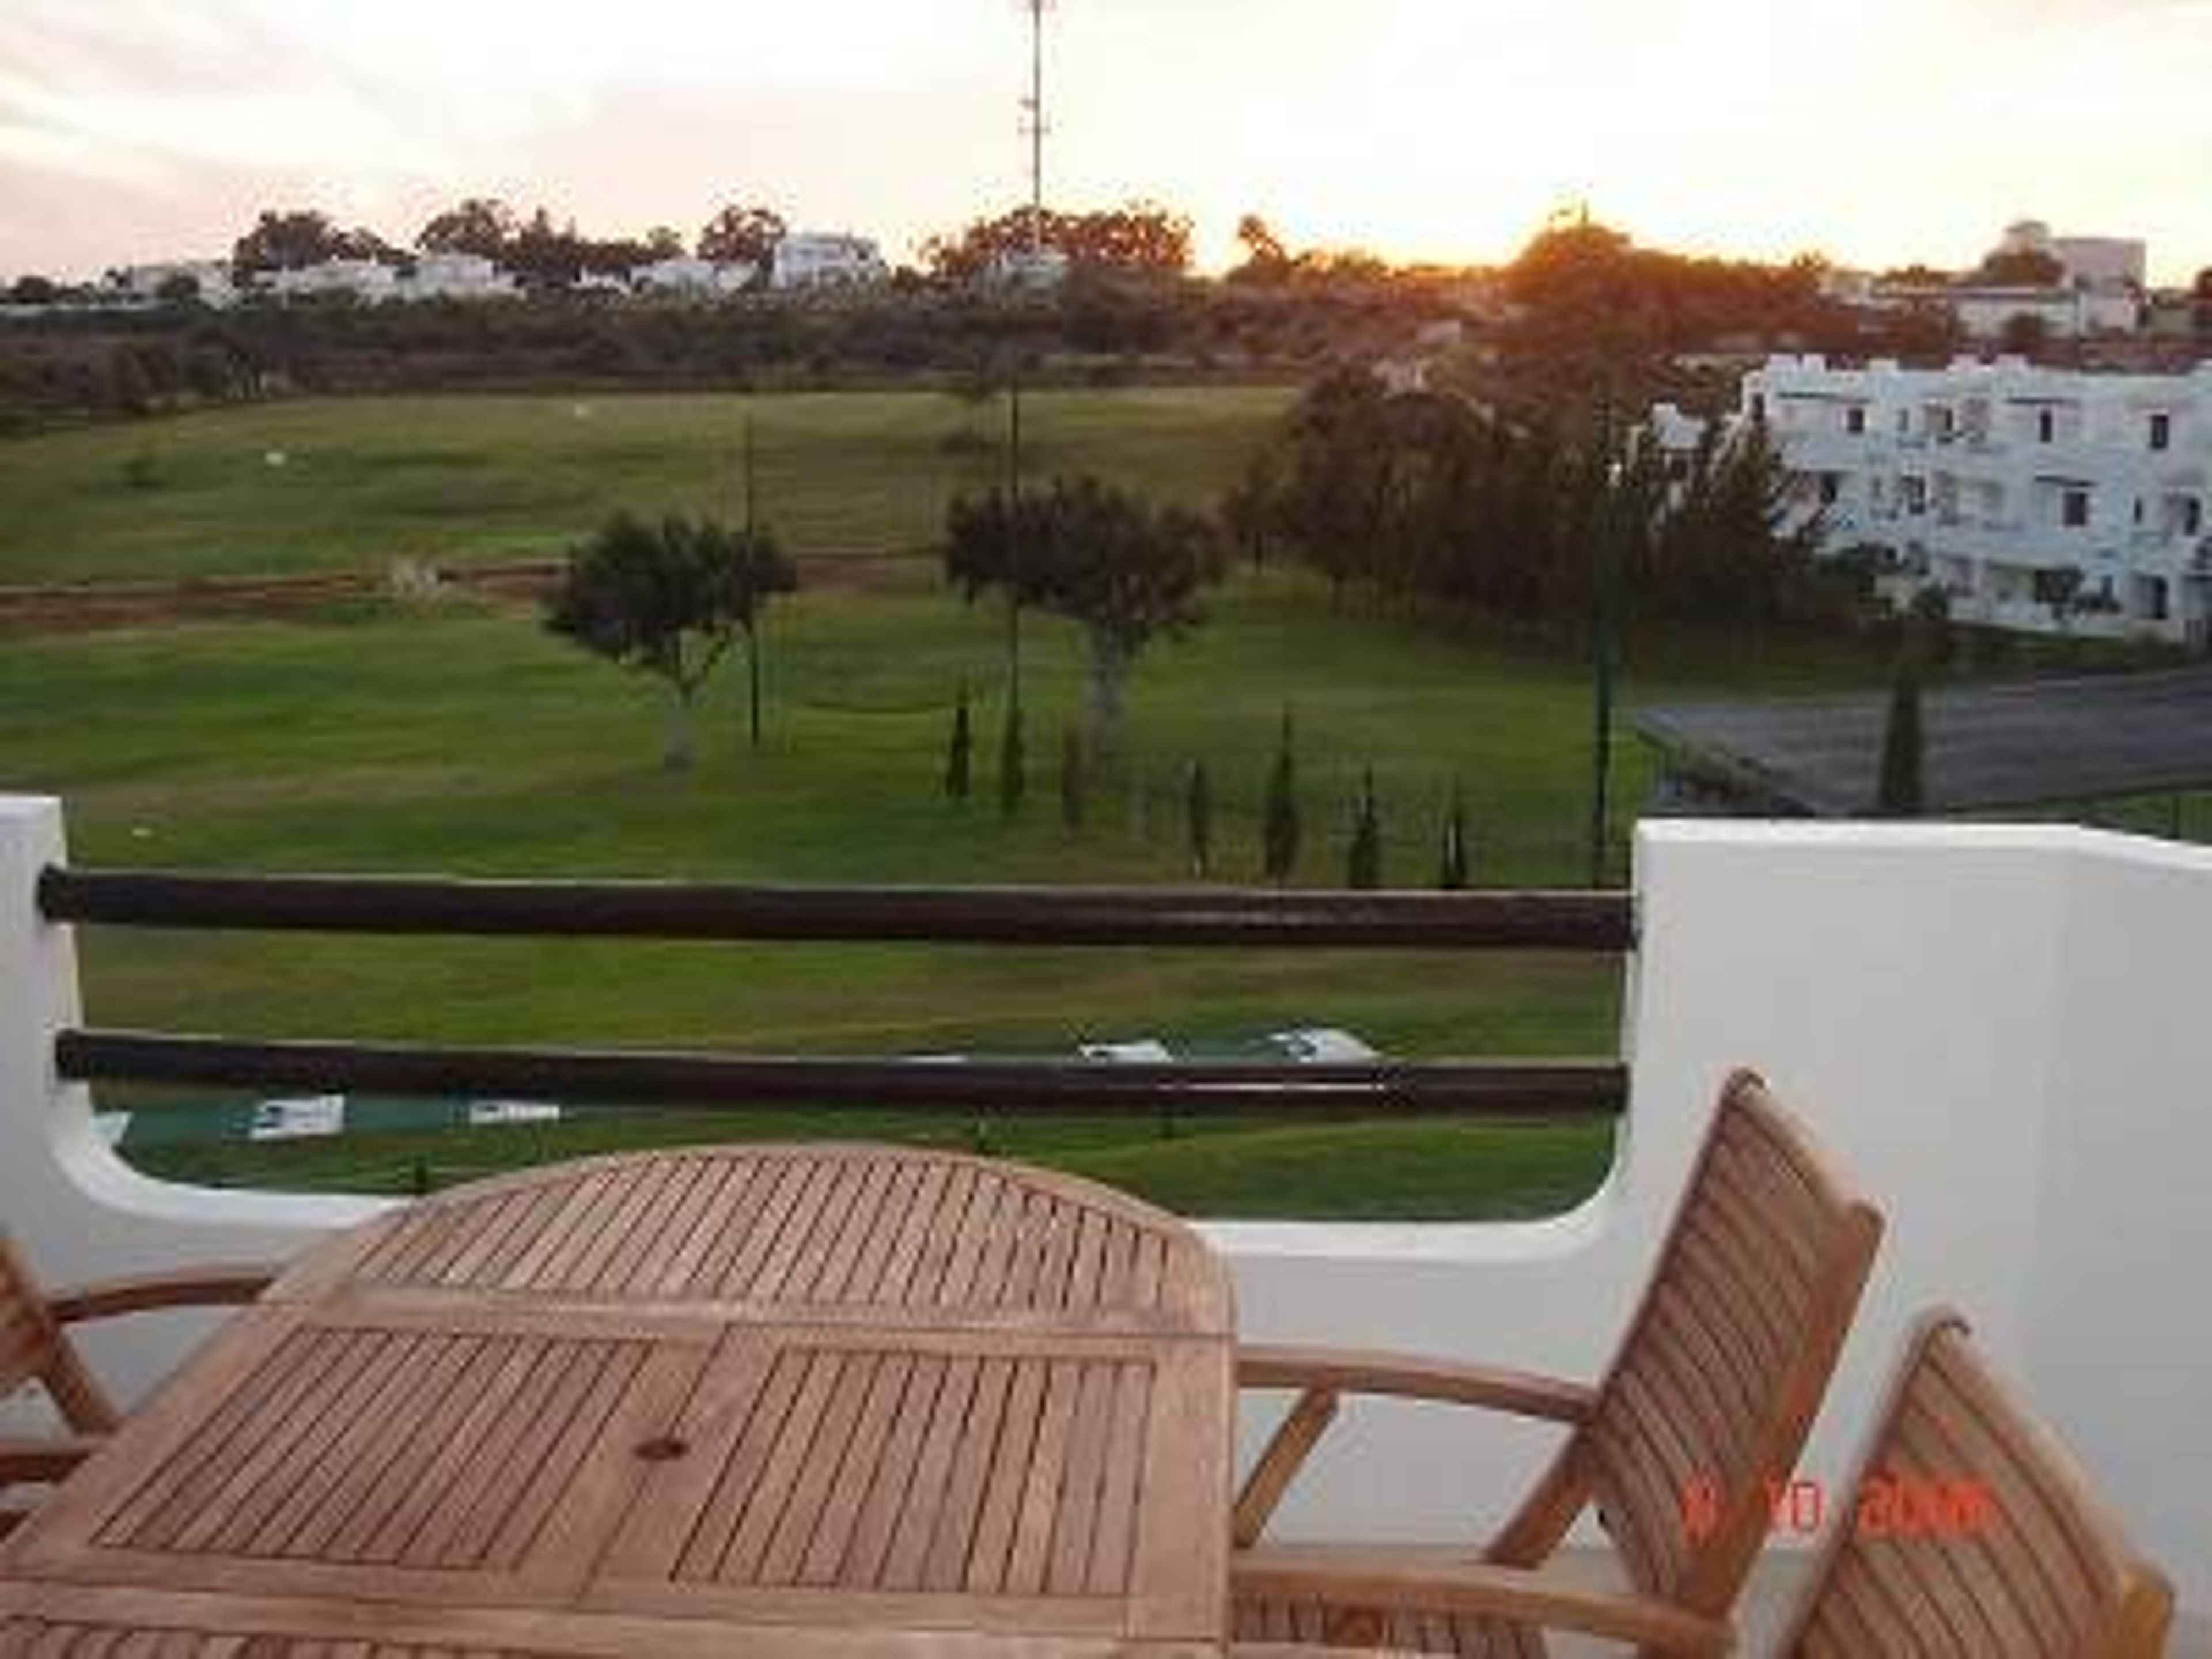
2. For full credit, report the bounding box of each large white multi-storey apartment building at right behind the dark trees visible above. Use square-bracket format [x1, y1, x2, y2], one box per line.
[1652, 356, 2212, 643]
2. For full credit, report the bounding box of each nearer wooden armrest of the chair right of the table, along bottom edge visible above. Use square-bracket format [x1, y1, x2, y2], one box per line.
[1230, 1546, 1736, 1659]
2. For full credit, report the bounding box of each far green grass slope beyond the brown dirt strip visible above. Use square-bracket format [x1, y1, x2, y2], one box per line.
[0, 387, 1292, 582]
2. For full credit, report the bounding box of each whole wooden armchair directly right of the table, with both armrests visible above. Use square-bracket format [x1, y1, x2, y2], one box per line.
[1234, 1071, 1883, 1654]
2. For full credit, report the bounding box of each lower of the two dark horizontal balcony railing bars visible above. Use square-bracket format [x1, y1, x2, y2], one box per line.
[53, 1031, 1628, 1117]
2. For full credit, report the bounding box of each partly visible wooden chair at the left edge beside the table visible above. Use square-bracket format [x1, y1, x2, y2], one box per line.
[0, 1232, 274, 1533]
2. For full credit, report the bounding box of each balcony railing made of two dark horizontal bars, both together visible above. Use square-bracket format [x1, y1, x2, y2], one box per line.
[37, 865, 1635, 1117]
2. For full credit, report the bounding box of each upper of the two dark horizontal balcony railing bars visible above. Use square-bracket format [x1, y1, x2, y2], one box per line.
[37, 865, 1635, 953]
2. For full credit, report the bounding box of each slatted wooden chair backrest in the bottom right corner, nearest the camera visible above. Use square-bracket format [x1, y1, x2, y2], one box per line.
[1778, 1312, 2172, 1659]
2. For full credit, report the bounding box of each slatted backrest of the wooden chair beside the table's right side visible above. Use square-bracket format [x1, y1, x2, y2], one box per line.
[1562, 1071, 1883, 1615]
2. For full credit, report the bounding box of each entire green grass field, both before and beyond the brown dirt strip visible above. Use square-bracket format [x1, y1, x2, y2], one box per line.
[0, 392, 1955, 1217]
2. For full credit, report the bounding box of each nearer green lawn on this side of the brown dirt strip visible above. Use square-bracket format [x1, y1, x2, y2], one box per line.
[0, 575, 1920, 1217]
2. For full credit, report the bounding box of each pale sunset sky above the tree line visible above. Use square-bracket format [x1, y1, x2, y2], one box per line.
[0, 0, 2212, 281]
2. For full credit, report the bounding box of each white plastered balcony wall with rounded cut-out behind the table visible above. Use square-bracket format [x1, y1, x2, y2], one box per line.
[0, 798, 2212, 1652]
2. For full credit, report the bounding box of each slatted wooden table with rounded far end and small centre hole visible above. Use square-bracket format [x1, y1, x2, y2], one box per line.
[0, 1146, 1234, 1659]
